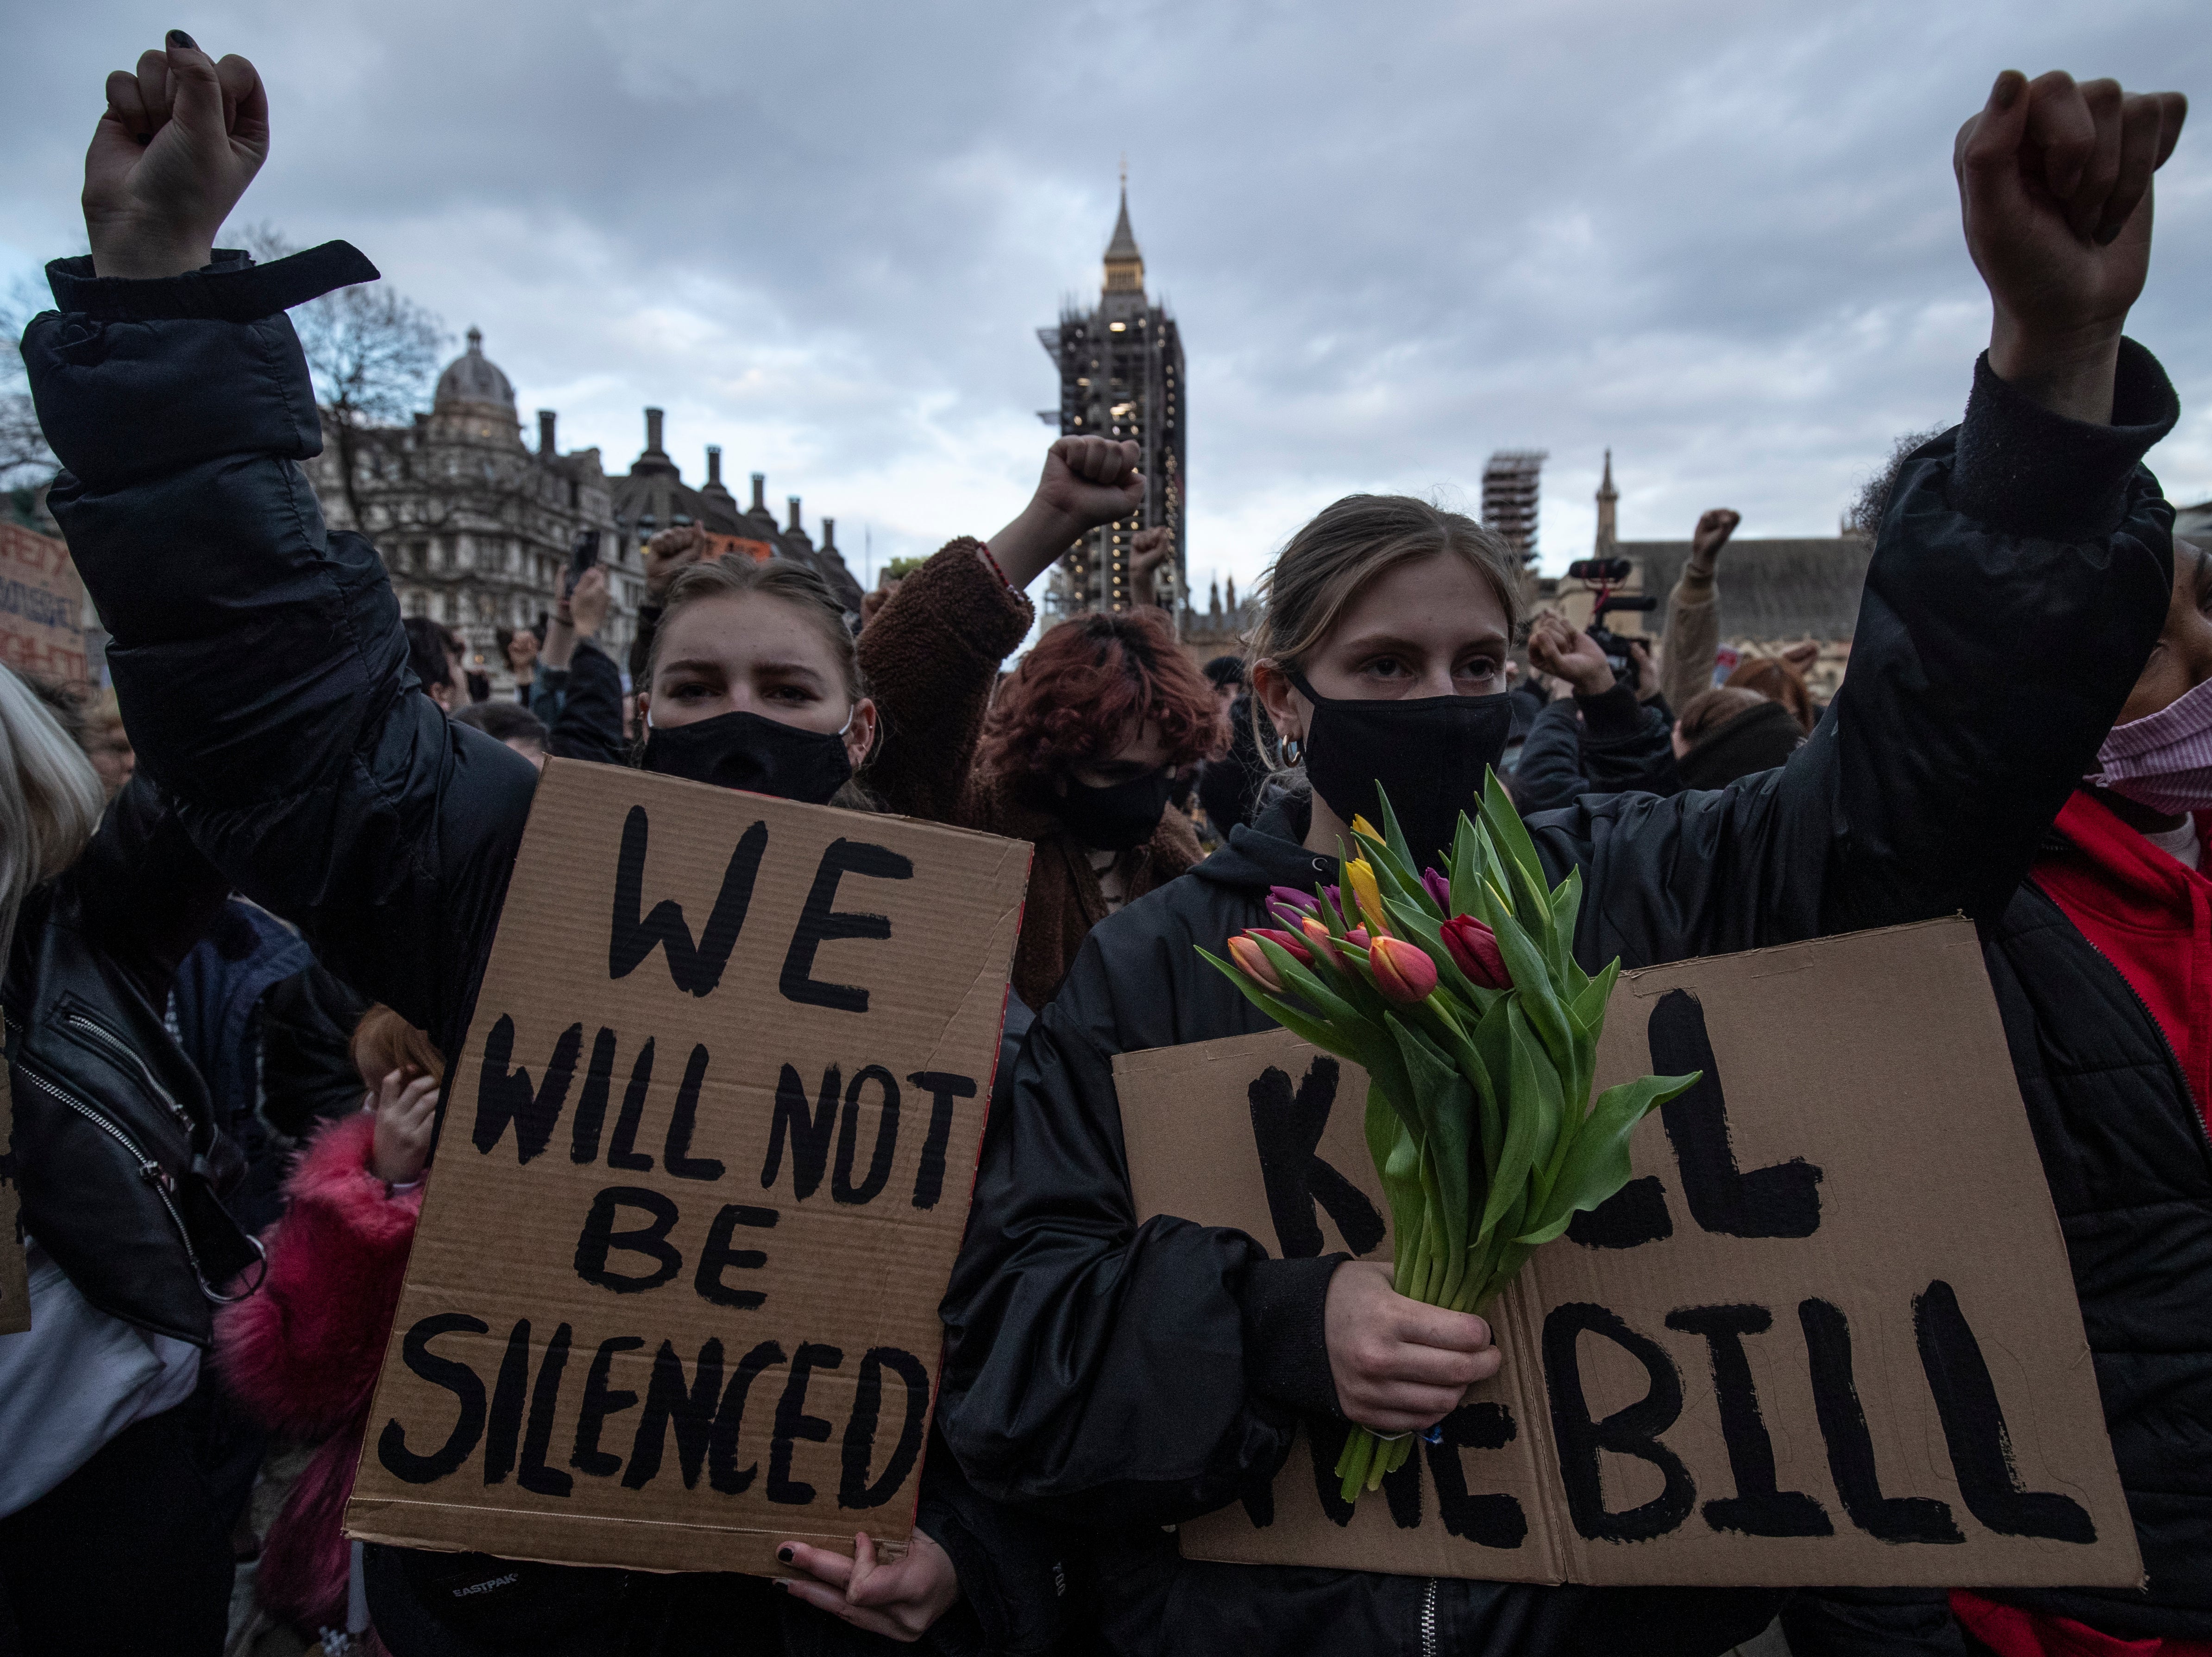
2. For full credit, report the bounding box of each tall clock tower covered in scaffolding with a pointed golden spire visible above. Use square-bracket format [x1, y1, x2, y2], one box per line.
[1037, 182, 1190, 622]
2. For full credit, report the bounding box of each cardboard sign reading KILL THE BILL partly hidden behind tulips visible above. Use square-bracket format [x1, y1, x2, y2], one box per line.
[1115, 920, 2141, 1586]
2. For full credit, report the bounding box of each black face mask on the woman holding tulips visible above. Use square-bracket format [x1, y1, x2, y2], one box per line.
[1289, 673, 1513, 869]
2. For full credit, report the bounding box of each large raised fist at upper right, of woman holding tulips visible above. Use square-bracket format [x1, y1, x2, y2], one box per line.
[1951, 69, 2187, 407]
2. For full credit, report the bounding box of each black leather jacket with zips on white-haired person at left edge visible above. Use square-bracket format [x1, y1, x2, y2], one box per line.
[0, 779, 254, 1345]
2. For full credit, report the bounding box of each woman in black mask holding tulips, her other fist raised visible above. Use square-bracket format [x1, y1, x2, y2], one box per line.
[938, 73, 2203, 1657]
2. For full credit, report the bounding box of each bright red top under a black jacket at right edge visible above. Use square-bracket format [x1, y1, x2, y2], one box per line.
[1951, 790, 2212, 1657]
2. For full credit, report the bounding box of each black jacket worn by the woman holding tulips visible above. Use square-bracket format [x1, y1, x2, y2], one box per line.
[940, 345, 2176, 1657]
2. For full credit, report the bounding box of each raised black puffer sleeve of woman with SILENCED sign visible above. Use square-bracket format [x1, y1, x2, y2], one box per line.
[25, 250, 538, 1053]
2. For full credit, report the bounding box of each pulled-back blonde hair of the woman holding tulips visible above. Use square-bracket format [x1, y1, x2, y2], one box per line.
[1245, 496, 1526, 770]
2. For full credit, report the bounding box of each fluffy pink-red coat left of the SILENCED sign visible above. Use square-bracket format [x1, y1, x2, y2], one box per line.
[214, 1110, 422, 1626]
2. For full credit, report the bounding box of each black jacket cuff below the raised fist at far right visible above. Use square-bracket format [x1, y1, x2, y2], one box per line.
[1951, 339, 2181, 540]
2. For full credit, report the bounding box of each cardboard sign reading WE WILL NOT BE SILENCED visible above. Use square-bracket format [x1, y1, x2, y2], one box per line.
[347, 759, 1029, 1573]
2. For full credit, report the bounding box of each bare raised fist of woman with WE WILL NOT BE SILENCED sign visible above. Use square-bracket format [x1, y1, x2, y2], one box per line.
[84, 29, 270, 277]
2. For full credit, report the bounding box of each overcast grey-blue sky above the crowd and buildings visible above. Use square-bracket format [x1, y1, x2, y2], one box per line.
[0, 0, 2212, 593]
